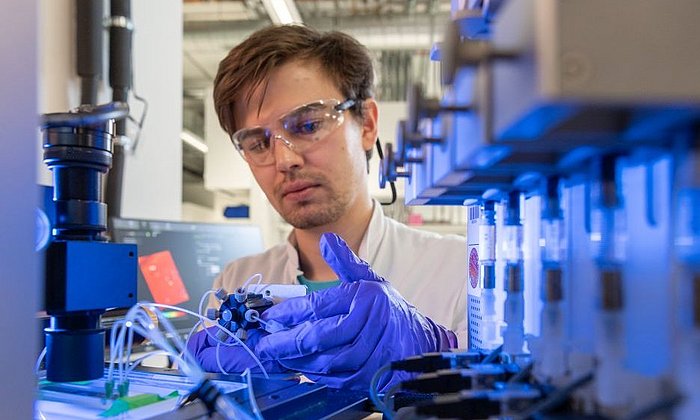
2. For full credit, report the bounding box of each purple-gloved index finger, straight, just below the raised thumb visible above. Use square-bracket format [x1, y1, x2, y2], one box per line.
[260, 284, 357, 328]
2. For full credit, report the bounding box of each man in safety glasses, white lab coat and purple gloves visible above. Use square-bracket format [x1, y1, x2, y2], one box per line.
[190, 26, 467, 389]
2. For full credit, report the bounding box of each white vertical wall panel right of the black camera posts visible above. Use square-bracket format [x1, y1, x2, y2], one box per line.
[122, 0, 182, 220]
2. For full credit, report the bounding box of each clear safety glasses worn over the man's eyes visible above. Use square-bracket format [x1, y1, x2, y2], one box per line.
[231, 99, 355, 166]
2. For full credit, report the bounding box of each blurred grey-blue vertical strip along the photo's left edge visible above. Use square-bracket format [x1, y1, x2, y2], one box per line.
[0, 0, 39, 419]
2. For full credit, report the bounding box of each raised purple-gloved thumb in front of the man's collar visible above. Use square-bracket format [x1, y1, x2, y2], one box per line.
[319, 232, 384, 283]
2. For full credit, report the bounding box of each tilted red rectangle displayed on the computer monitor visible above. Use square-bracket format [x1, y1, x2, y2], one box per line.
[139, 251, 190, 305]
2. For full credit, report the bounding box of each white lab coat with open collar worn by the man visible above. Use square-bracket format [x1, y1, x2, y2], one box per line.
[214, 202, 467, 348]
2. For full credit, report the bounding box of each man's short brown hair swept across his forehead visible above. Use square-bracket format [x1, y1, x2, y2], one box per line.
[214, 25, 374, 135]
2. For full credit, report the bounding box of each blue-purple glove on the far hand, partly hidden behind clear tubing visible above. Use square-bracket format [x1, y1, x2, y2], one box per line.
[187, 327, 287, 374]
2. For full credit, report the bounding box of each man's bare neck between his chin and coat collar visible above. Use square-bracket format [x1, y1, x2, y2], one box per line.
[294, 200, 373, 280]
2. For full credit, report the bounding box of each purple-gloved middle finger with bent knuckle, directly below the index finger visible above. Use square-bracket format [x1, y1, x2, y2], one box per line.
[257, 281, 390, 360]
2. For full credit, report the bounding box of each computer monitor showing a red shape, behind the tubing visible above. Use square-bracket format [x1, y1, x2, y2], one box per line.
[111, 218, 263, 332]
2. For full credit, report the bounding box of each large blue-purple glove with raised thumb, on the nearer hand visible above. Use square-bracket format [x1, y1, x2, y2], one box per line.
[256, 233, 457, 390]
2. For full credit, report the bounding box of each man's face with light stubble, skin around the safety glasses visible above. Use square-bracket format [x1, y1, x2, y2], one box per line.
[234, 61, 376, 229]
